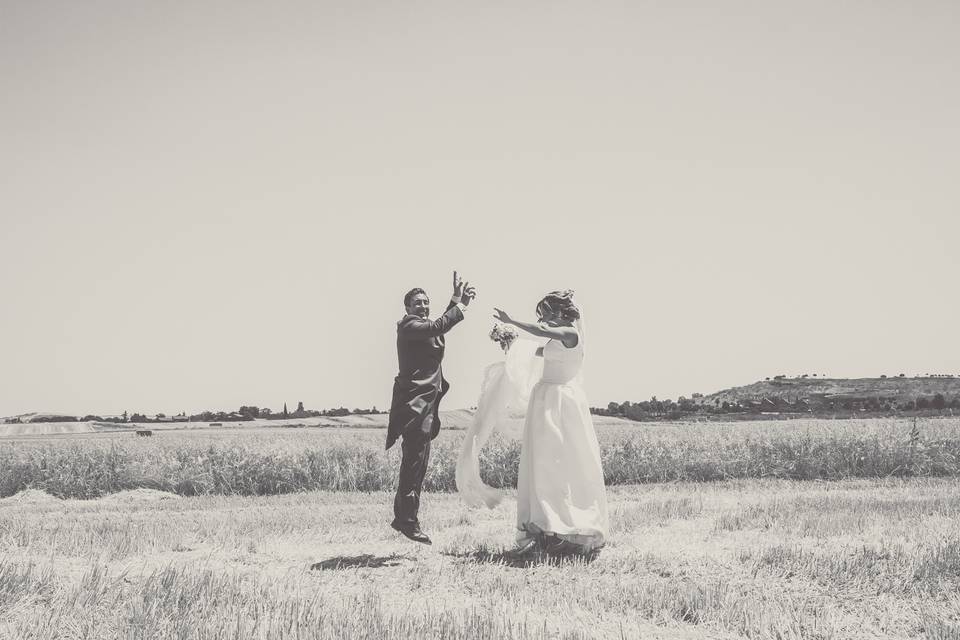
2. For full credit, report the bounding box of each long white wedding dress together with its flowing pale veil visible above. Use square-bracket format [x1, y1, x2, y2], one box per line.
[457, 326, 609, 549]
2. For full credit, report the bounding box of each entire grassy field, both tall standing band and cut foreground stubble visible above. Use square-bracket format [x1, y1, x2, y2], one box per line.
[0, 420, 960, 638]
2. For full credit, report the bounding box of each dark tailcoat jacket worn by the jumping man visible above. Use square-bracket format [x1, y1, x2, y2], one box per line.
[387, 301, 463, 449]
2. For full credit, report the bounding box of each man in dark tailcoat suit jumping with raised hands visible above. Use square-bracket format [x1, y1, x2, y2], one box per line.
[387, 271, 477, 544]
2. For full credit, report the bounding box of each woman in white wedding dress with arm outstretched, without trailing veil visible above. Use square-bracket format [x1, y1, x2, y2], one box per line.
[495, 290, 609, 554]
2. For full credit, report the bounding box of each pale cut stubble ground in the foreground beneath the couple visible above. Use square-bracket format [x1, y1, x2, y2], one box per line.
[0, 479, 960, 639]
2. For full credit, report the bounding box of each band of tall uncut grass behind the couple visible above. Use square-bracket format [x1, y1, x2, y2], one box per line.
[0, 420, 960, 498]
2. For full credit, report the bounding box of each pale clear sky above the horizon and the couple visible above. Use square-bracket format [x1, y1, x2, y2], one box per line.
[0, 0, 960, 415]
